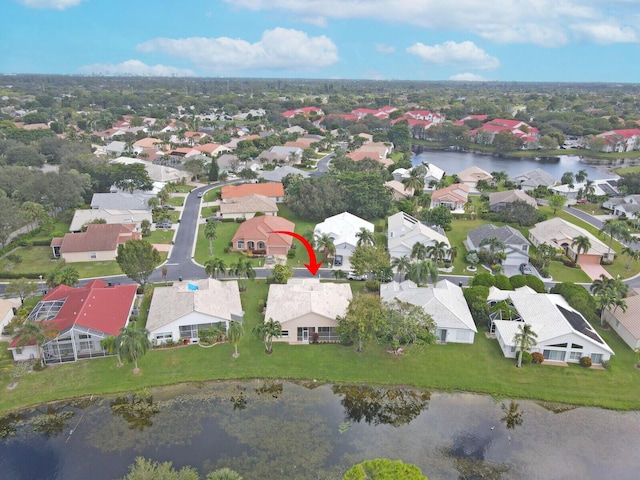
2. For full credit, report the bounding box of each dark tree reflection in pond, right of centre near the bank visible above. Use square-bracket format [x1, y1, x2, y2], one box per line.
[333, 385, 431, 427]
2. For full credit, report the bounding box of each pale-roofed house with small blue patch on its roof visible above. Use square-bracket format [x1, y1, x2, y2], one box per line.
[147, 278, 244, 344]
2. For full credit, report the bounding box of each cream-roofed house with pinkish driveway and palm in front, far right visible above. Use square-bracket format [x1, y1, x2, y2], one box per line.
[529, 217, 616, 264]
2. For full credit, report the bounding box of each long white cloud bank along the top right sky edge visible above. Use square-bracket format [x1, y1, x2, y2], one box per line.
[225, 0, 638, 47]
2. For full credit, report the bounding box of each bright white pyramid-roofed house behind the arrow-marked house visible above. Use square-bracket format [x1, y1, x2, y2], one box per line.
[313, 212, 374, 271]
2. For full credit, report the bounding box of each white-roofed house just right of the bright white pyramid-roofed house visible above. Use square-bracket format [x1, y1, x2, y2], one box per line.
[387, 212, 451, 258]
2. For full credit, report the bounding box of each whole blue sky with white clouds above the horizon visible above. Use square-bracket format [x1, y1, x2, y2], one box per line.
[0, 0, 640, 83]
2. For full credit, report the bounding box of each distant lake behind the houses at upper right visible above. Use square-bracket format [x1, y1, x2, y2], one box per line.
[412, 150, 634, 180]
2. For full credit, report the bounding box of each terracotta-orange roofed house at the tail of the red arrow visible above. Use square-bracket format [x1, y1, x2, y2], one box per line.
[231, 216, 295, 255]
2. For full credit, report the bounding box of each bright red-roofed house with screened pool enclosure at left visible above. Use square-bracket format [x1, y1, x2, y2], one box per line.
[9, 280, 138, 363]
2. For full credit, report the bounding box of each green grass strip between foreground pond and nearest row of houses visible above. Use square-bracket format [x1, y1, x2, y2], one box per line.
[0, 281, 640, 412]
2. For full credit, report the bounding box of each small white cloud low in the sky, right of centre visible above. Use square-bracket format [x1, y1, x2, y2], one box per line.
[407, 41, 500, 70]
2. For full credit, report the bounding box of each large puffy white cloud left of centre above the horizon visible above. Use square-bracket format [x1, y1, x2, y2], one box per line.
[137, 28, 338, 73]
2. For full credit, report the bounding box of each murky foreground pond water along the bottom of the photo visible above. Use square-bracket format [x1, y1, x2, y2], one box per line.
[0, 380, 640, 480]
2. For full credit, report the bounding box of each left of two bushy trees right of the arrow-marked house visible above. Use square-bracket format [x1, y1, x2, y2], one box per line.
[336, 294, 385, 353]
